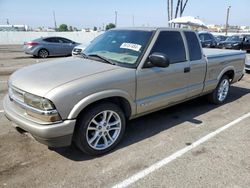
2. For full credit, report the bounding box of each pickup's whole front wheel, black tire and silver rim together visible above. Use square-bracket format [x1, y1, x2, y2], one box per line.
[75, 103, 126, 155]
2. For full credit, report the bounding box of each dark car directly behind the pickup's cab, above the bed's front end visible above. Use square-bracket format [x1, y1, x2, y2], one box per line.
[198, 31, 217, 48]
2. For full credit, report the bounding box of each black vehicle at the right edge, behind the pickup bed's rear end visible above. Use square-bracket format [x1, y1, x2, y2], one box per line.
[218, 34, 250, 51]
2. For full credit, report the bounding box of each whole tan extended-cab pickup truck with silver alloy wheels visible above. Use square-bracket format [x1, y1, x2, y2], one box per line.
[3, 28, 246, 155]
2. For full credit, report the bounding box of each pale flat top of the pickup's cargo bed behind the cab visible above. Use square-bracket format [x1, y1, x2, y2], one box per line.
[203, 48, 246, 59]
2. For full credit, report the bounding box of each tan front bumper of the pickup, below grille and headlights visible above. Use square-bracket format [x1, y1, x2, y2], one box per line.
[3, 96, 76, 147]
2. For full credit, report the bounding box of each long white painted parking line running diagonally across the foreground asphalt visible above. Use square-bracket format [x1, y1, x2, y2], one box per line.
[112, 112, 250, 188]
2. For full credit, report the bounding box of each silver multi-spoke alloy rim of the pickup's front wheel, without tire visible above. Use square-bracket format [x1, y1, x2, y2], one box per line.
[86, 110, 121, 150]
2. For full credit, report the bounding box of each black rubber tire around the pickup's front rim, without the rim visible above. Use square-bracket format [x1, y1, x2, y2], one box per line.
[74, 102, 126, 155]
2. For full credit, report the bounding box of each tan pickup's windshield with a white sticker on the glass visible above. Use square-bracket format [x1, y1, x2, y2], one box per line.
[83, 30, 153, 67]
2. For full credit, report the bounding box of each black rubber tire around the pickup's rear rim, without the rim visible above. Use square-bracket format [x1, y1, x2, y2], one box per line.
[208, 75, 230, 104]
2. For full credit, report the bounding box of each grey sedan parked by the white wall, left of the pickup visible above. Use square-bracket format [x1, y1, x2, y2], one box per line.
[23, 37, 79, 58]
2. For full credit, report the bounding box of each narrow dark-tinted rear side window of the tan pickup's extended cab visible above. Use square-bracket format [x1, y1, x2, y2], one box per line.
[184, 31, 202, 61]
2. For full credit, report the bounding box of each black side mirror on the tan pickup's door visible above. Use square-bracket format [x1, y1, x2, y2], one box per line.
[148, 53, 170, 68]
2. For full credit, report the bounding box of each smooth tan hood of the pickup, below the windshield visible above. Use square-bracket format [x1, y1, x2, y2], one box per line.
[9, 57, 119, 97]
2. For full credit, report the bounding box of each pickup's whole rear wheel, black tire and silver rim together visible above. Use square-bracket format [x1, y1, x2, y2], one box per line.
[208, 75, 230, 104]
